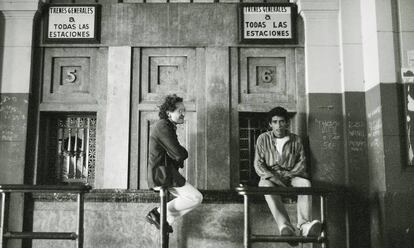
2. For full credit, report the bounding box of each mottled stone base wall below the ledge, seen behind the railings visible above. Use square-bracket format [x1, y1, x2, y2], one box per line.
[32, 201, 300, 248]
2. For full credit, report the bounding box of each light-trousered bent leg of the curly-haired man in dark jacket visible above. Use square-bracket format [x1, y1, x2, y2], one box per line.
[167, 183, 203, 224]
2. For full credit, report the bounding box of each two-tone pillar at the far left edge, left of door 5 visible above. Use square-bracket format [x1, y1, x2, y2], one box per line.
[0, 0, 38, 247]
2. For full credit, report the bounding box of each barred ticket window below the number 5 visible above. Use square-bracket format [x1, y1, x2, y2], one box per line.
[38, 113, 96, 185]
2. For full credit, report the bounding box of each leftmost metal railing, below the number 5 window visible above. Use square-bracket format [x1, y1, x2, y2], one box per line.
[0, 184, 92, 248]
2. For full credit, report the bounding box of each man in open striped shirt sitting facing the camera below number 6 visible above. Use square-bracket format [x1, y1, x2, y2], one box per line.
[254, 107, 322, 245]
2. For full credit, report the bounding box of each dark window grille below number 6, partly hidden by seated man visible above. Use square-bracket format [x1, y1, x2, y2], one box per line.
[239, 112, 268, 186]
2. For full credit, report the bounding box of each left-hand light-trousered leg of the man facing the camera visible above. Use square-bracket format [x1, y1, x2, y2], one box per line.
[259, 179, 294, 231]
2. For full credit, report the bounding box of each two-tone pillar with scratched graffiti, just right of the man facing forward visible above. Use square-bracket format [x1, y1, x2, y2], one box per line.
[297, 0, 346, 248]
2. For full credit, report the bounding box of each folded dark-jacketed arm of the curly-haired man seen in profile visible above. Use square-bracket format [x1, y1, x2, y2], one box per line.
[156, 123, 188, 162]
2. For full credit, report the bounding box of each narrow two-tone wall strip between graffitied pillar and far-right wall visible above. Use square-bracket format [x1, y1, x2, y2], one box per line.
[340, 0, 370, 247]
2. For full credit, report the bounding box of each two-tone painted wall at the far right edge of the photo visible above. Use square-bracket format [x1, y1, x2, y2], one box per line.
[361, 1, 414, 247]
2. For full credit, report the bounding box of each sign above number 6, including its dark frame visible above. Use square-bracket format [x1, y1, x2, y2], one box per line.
[239, 3, 298, 44]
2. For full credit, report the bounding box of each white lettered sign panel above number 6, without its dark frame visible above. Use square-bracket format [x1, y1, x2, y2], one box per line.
[243, 6, 292, 39]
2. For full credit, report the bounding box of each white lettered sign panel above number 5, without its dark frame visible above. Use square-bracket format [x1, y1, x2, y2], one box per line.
[47, 6, 96, 39]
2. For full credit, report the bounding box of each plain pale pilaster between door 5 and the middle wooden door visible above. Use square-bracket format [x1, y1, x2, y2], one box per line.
[101, 46, 131, 189]
